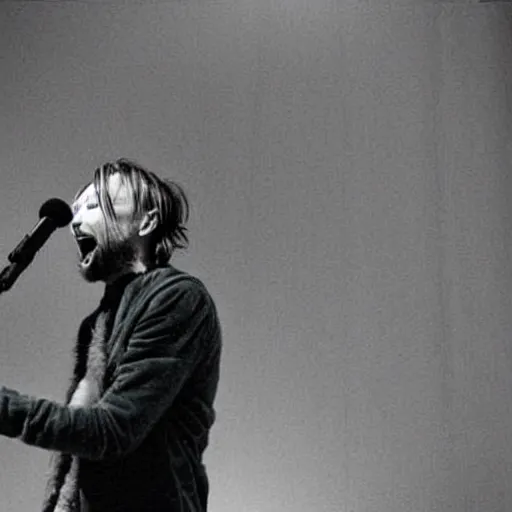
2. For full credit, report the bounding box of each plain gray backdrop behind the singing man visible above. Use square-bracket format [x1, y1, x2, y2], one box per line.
[0, 0, 512, 512]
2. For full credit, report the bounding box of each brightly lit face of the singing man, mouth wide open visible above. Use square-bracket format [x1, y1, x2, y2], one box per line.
[71, 174, 139, 282]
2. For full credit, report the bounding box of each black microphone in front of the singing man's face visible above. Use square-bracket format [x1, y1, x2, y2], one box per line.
[0, 198, 73, 292]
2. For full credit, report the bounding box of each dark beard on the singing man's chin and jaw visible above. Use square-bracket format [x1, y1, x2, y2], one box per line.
[78, 233, 137, 283]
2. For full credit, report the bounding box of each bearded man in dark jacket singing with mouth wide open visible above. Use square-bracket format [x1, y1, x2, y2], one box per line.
[0, 159, 221, 512]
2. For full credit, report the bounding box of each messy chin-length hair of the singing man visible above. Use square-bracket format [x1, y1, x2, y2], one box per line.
[75, 158, 190, 266]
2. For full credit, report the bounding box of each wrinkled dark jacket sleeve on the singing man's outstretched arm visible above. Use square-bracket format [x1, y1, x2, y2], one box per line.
[0, 279, 213, 460]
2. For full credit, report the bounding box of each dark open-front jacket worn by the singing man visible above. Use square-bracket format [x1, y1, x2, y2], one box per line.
[0, 266, 221, 512]
